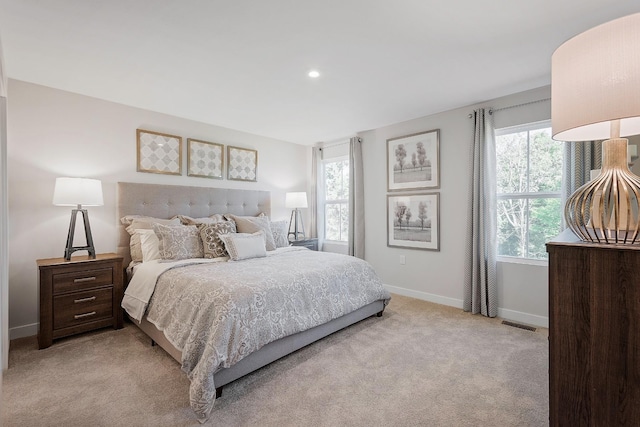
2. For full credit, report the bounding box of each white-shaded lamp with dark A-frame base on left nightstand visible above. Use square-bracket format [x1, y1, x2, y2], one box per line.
[53, 178, 104, 261]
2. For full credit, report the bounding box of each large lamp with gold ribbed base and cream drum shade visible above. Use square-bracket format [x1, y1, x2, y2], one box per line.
[551, 13, 640, 244]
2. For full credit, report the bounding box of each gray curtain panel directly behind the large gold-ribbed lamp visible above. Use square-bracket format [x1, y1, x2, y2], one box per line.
[562, 141, 602, 229]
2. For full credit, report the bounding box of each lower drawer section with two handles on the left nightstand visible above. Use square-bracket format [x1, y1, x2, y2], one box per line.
[53, 287, 113, 329]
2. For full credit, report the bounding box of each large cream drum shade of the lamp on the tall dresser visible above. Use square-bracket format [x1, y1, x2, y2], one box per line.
[551, 13, 640, 141]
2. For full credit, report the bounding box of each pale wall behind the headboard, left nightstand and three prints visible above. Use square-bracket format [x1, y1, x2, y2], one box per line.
[7, 80, 310, 338]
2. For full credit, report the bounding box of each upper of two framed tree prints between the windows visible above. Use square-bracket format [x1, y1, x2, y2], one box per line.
[387, 129, 440, 191]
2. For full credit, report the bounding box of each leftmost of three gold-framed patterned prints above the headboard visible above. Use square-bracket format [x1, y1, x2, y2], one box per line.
[136, 129, 182, 175]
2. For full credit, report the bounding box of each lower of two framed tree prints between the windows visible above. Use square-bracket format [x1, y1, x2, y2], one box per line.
[387, 193, 440, 251]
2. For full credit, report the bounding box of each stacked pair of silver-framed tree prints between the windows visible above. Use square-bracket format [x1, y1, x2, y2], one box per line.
[387, 129, 440, 251]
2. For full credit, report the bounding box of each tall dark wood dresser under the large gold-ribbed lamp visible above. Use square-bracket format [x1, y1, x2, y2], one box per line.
[547, 230, 640, 427]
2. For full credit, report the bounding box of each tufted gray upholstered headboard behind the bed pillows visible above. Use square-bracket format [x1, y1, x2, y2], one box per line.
[117, 182, 271, 267]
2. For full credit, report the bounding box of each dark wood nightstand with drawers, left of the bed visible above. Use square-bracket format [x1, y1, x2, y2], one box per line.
[37, 253, 123, 349]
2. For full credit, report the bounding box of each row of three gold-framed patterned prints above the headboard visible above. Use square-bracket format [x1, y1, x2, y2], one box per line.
[136, 129, 258, 182]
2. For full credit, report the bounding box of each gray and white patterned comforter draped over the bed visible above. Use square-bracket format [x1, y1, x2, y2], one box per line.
[123, 247, 391, 422]
